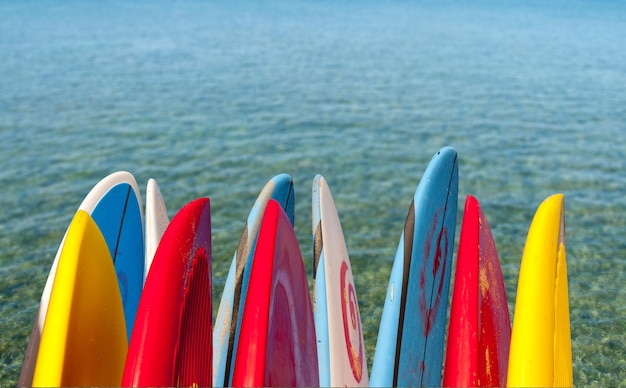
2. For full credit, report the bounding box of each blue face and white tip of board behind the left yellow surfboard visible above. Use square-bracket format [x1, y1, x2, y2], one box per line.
[80, 171, 144, 342]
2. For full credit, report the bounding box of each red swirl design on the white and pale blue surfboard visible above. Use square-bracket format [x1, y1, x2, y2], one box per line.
[340, 261, 365, 382]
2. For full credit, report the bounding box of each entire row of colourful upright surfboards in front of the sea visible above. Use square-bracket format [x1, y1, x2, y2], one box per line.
[19, 147, 572, 387]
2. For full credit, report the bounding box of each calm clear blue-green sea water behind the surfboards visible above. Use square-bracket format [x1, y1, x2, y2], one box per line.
[0, 0, 626, 387]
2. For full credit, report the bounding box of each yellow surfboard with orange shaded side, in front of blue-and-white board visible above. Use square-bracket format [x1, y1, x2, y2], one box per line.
[33, 210, 128, 387]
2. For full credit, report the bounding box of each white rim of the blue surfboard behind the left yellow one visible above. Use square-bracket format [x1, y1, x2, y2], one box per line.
[18, 171, 143, 387]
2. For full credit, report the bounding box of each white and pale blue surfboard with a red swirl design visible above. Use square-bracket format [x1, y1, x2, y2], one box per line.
[312, 175, 368, 387]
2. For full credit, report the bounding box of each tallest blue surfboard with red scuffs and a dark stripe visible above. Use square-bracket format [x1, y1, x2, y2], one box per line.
[370, 147, 458, 387]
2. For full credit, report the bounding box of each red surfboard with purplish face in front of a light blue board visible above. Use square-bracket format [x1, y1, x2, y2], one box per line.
[232, 199, 319, 387]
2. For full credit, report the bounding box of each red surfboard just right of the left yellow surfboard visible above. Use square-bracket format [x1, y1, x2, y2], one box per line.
[118, 198, 212, 387]
